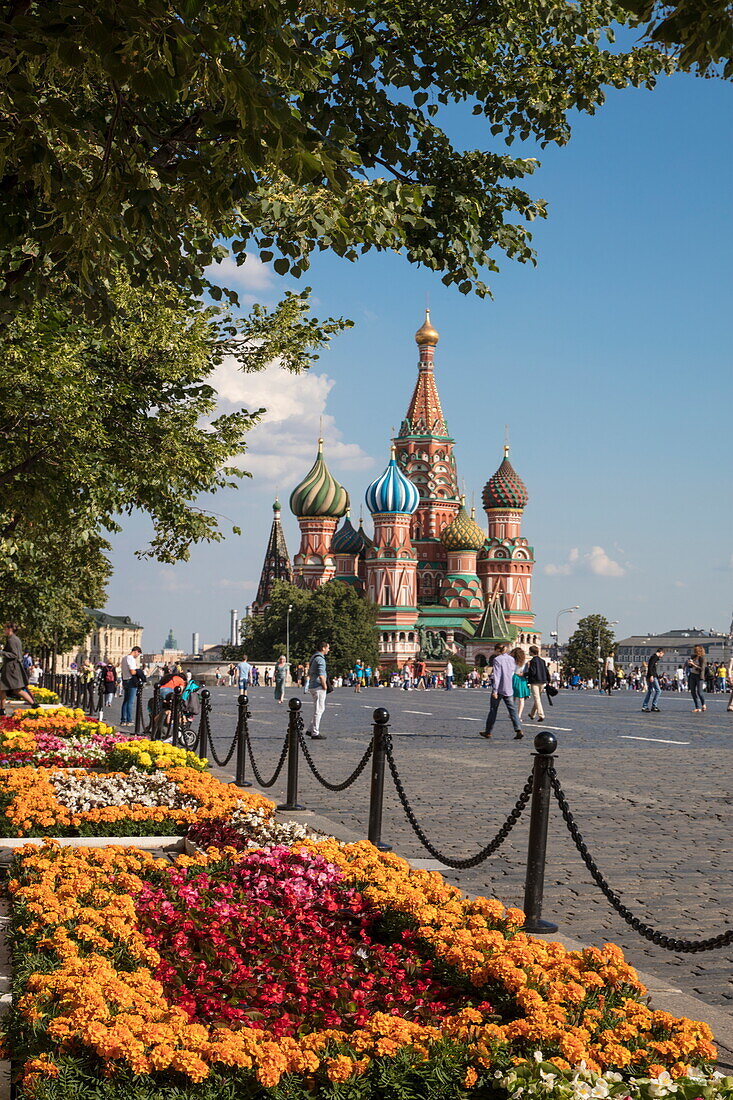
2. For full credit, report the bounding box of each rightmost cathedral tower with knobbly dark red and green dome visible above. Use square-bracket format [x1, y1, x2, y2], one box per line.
[478, 447, 535, 640]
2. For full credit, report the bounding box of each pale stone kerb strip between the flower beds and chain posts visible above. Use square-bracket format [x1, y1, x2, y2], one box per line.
[268, 788, 733, 1073]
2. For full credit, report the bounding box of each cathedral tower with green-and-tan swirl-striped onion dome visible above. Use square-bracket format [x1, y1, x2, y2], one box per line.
[291, 439, 349, 589]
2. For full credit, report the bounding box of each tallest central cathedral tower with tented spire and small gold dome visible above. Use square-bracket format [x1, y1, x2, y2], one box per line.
[395, 309, 460, 604]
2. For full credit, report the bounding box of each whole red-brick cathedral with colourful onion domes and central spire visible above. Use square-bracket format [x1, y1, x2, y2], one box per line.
[252, 310, 539, 667]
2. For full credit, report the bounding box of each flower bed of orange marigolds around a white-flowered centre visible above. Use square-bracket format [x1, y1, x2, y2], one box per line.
[0, 767, 272, 837]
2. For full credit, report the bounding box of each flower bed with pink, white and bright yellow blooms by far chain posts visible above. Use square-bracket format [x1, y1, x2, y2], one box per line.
[0, 708, 208, 771]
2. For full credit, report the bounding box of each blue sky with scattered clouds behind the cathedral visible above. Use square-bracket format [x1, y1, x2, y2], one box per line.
[108, 66, 733, 650]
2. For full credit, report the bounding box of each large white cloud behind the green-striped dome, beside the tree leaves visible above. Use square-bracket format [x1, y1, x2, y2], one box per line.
[212, 356, 373, 494]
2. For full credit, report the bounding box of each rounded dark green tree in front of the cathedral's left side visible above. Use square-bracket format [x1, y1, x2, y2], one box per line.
[242, 581, 379, 675]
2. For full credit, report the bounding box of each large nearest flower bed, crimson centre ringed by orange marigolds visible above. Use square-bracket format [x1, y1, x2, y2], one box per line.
[3, 836, 733, 1100]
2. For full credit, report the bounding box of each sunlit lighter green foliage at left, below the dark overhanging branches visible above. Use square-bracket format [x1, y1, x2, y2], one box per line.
[0, 277, 340, 573]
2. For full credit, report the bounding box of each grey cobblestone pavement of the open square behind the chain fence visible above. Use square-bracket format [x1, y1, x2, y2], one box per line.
[197, 688, 733, 1009]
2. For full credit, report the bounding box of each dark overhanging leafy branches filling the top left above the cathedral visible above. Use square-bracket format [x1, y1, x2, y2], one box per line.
[0, 0, 668, 316]
